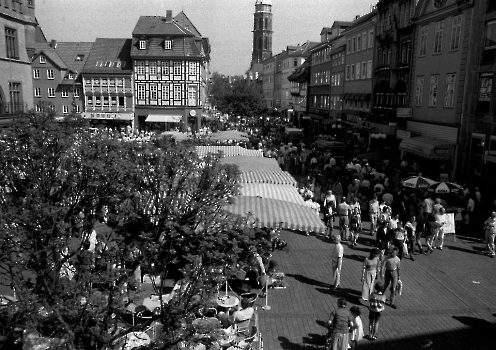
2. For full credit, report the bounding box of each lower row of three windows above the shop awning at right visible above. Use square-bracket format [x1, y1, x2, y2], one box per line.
[415, 73, 456, 108]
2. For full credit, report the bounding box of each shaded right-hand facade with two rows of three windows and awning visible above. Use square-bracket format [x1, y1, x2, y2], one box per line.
[399, 0, 473, 180]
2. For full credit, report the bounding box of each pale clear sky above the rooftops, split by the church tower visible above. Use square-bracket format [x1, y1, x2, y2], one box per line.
[36, 0, 378, 75]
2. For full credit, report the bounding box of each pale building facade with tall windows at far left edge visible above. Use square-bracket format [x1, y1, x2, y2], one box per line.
[0, 0, 38, 119]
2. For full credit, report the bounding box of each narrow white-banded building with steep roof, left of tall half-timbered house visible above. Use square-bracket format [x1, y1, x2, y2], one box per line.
[81, 38, 134, 129]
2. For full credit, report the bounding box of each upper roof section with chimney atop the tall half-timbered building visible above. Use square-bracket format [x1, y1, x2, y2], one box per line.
[133, 16, 196, 36]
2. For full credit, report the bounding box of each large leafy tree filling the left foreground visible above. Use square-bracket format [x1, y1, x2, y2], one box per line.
[0, 111, 266, 349]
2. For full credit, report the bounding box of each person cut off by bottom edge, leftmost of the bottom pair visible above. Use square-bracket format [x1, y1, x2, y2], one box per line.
[327, 298, 353, 350]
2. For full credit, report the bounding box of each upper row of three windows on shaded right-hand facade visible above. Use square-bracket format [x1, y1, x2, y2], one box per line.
[419, 15, 462, 56]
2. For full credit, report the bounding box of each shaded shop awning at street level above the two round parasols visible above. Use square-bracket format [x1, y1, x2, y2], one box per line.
[399, 136, 454, 159]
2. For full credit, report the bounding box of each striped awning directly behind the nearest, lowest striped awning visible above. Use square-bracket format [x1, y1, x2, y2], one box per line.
[240, 183, 305, 205]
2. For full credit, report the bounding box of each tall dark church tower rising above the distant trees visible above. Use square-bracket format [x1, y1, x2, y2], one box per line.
[251, 0, 272, 66]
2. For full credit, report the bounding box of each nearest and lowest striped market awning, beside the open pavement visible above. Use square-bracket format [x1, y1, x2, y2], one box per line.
[225, 196, 326, 233]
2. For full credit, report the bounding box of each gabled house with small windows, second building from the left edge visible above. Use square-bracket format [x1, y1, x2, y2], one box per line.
[31, 40, 93, 117]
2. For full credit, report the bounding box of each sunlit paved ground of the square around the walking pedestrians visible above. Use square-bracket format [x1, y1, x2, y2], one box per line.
[256, 224, 496, 350]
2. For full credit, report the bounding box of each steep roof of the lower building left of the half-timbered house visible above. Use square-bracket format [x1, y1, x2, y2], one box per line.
[83, 38, 133, 74]
